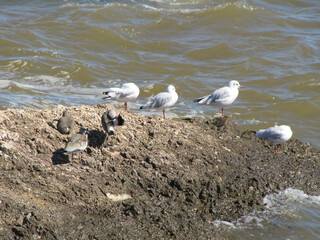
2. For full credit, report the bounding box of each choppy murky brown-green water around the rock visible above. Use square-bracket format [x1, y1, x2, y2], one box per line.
[0, 0, 320, 239]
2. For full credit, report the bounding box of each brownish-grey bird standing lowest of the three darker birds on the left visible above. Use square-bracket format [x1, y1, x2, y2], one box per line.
[64, 127, 89, 161]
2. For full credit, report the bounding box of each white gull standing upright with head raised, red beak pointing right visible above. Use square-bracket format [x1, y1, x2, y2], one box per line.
[194, 80, 243, 117]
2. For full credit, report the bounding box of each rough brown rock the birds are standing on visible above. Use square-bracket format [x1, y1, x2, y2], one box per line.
[0, 105, 320, 239]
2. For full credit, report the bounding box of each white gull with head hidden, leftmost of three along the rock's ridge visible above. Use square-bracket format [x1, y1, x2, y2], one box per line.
[103, 83, 140, 112]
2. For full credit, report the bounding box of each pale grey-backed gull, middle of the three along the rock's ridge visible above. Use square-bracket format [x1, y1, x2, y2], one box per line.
[140, 85, 178, 119]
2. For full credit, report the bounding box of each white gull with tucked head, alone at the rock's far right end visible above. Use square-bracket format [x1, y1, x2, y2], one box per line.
[256, 125, 292, 153]
